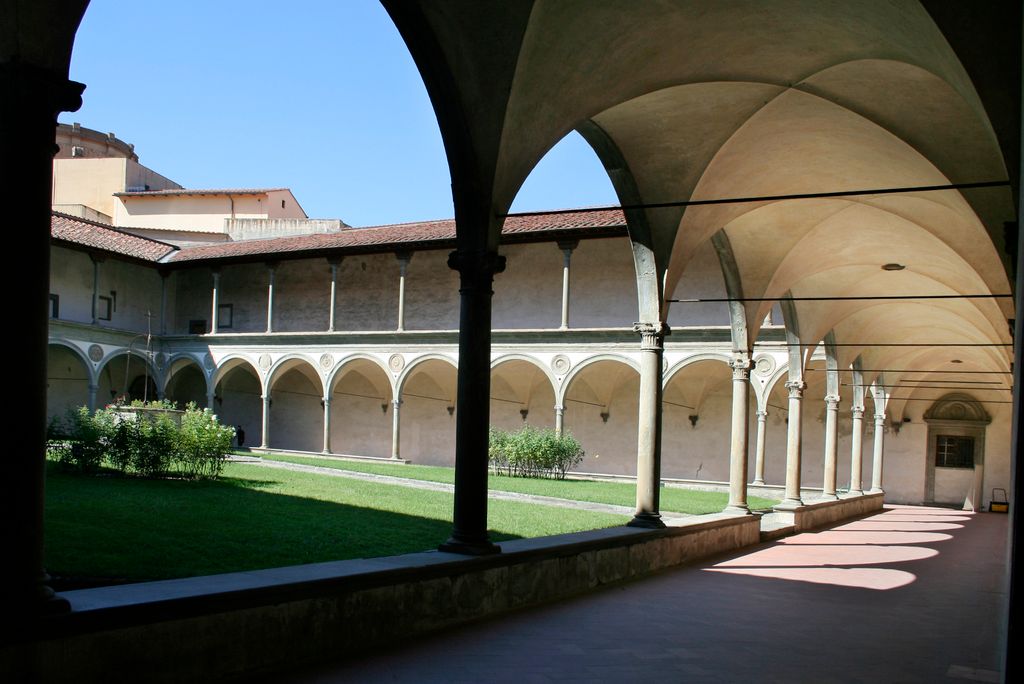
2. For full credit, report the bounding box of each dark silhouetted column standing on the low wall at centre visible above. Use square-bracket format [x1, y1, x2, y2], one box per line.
[440, 250, 505, 555]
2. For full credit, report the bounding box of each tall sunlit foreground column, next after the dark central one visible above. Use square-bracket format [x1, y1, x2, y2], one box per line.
[627, 323, 669, 527]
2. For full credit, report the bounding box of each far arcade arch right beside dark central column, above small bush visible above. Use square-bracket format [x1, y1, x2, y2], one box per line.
[490, 354, 558, 429]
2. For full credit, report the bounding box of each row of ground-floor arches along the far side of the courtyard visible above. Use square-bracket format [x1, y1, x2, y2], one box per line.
[50, 340, 905, 482]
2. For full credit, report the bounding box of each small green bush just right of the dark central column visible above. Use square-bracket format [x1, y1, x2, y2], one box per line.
[487, 425, 584, 479]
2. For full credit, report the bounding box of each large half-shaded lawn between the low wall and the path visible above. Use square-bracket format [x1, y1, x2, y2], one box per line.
[46, 464, 625, 581]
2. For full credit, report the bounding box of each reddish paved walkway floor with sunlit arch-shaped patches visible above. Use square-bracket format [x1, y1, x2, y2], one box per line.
[273, 507, 1008, 684]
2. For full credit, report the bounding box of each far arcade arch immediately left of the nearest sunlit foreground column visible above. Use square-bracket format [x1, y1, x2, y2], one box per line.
[559, 354, 640, 475]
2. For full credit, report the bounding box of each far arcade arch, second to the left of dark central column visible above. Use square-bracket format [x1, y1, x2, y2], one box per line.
[327, 354, 394, 458]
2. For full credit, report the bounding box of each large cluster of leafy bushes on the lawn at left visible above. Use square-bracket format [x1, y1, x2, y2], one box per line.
[47, 400, 234, 479]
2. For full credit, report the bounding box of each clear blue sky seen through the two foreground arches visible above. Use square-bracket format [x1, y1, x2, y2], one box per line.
[68, 0, 616, 225]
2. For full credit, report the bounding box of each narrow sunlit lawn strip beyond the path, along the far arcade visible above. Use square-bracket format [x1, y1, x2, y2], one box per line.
[263, 454, 778, 515]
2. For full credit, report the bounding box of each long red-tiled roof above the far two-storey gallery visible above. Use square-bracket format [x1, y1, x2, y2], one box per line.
[168, 209, 626, 263]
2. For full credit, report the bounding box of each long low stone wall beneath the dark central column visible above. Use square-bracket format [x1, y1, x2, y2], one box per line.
[0, 514, 760, 682]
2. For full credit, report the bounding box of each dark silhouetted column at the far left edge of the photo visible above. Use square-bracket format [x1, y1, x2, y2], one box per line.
[0, 61, 84, 618]
